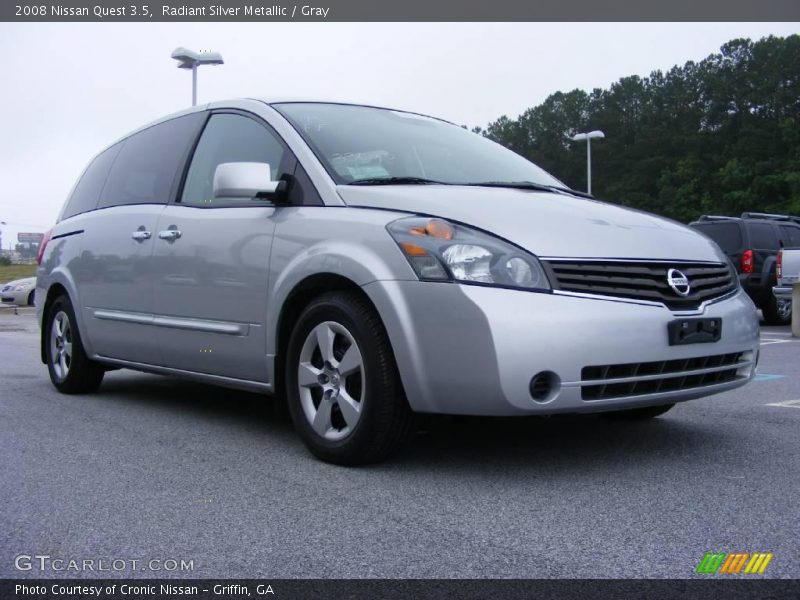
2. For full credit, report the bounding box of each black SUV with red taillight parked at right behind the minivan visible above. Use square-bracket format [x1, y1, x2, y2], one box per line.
[689, 212, 800, 325]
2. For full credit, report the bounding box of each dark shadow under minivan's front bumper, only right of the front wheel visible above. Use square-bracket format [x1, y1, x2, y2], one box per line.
[396, 405, 736, 474]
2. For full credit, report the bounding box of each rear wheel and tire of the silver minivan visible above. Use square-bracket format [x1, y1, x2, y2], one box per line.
[42, 295, 105, 394]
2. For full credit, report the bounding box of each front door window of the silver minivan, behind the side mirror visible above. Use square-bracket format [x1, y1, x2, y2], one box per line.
[181, 114, 285, 205]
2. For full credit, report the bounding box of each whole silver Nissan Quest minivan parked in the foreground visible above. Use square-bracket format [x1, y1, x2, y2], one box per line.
[35, 100, 759, 464]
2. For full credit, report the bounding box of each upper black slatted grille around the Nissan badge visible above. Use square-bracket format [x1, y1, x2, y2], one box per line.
[545, 260, 736, 310]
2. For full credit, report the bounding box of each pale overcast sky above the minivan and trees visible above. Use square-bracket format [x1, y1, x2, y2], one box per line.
[0, 23, 800, 248]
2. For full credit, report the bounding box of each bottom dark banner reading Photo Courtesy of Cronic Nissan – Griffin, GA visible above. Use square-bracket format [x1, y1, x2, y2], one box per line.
[0, 578, 800, 600]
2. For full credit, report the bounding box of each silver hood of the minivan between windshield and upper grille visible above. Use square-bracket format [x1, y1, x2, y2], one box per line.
[337, 185, 727, 262]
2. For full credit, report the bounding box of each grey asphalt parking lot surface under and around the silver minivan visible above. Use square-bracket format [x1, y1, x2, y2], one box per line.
[0, 311, 800, 578]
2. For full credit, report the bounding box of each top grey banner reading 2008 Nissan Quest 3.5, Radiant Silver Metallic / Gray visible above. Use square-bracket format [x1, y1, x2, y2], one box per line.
[0, 0, 800, 22]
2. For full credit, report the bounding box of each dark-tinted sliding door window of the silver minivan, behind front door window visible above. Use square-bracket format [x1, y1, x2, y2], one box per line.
[99, 113, 204, 208]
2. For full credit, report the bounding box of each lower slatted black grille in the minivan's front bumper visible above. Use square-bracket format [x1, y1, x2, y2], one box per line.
[581, 352, 751, 401]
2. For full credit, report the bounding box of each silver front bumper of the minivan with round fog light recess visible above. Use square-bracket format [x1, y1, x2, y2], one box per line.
[364, 281, 759, 415]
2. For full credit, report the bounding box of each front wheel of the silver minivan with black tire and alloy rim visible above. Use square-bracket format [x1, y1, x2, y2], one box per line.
[285, 292, 415, 466]
